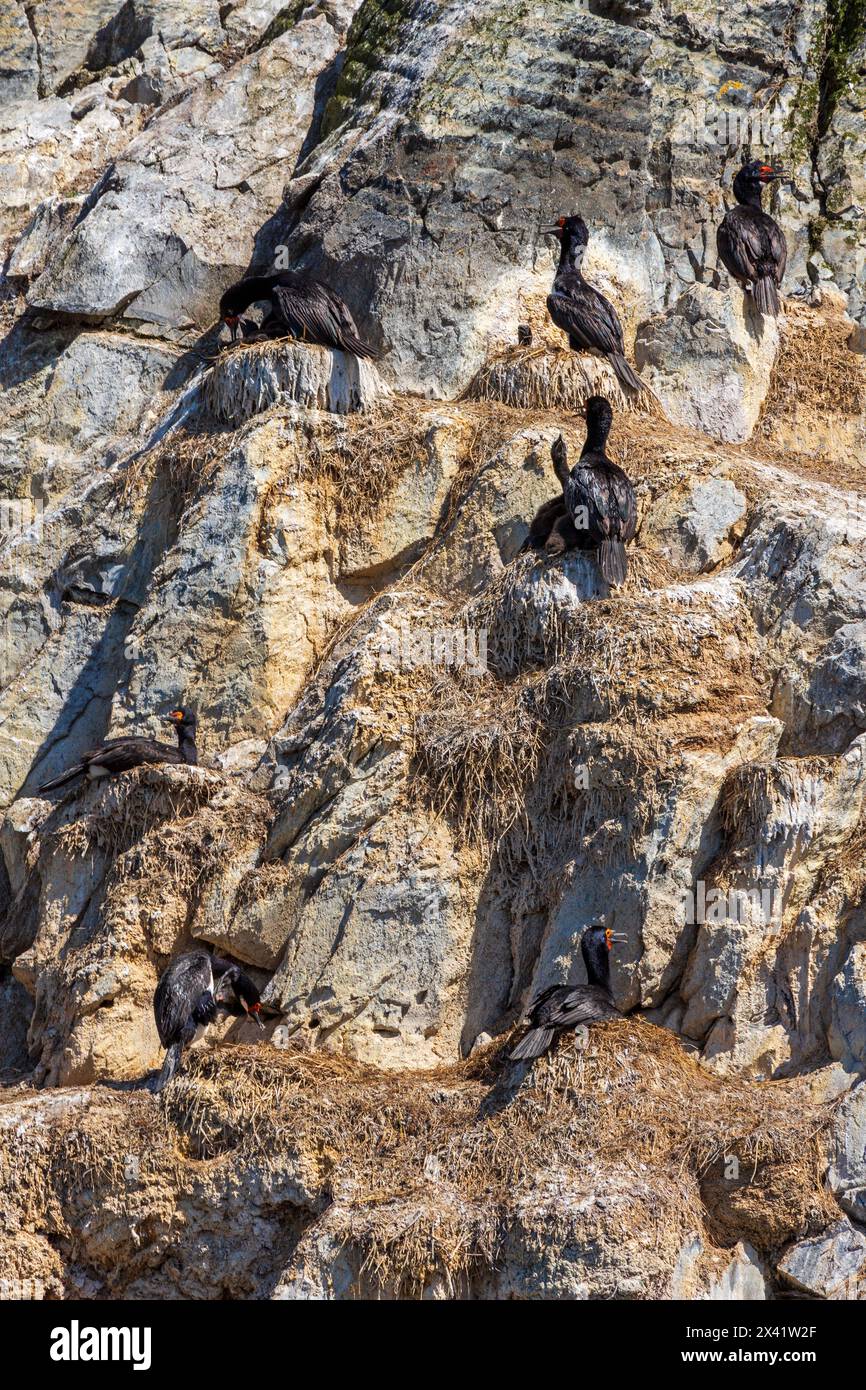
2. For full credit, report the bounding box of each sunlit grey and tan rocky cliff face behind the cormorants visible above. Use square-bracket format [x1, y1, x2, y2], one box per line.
[0, 0, 866, 1298]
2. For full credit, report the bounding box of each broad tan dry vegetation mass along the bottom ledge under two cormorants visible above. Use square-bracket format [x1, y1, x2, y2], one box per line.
[147, 1019, 830, 1295]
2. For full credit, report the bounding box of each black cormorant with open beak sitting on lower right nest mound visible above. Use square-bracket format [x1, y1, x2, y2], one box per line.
[509, 923, 626, 1062]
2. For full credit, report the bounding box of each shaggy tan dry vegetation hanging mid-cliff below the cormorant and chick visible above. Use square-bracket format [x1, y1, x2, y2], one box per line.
[413, 562, 766, 848]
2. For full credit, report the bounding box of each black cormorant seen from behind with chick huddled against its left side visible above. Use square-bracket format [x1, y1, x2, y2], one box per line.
[545, 396, 638, 585]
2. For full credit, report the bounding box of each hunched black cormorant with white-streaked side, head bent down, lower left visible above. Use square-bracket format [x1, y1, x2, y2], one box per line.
[153, 951, 264, 1093]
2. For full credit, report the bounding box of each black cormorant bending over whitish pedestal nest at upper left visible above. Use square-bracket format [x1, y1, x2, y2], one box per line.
[220, 270, 375, 357]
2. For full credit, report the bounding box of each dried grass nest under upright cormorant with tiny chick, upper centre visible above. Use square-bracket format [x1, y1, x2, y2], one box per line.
[466, 346, 662, 417]
